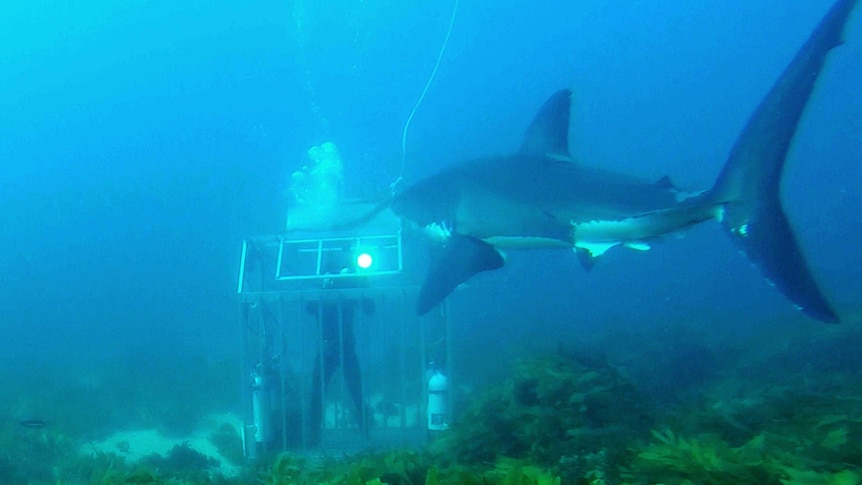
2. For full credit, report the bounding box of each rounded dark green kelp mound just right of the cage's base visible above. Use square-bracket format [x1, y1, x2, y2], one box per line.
[431, 355, 650, 483]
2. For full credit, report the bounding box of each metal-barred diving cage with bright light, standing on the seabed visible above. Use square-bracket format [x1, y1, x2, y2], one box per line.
[237, 201, 451, 458]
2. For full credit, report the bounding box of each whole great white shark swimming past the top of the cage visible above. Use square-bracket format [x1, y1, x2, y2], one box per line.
[352, 0, 856, 322]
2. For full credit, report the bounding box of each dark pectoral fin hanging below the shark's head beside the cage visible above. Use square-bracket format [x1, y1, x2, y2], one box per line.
[416, 234, 504, 315]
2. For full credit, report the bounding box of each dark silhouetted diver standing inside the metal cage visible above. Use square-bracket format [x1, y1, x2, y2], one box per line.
[306, 242, 375, 446]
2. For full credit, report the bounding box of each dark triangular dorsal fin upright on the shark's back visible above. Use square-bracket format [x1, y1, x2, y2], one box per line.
[521, 89, 572, 158]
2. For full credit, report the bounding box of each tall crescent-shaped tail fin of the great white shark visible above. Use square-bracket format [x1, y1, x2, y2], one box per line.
[709, 0, 857, 322]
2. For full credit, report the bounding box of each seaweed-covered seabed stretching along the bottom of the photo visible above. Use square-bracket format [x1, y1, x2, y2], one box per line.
[6, 322, 862, 485]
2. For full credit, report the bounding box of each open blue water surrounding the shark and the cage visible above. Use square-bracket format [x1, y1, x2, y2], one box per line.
[0, 0, 862, 398]
